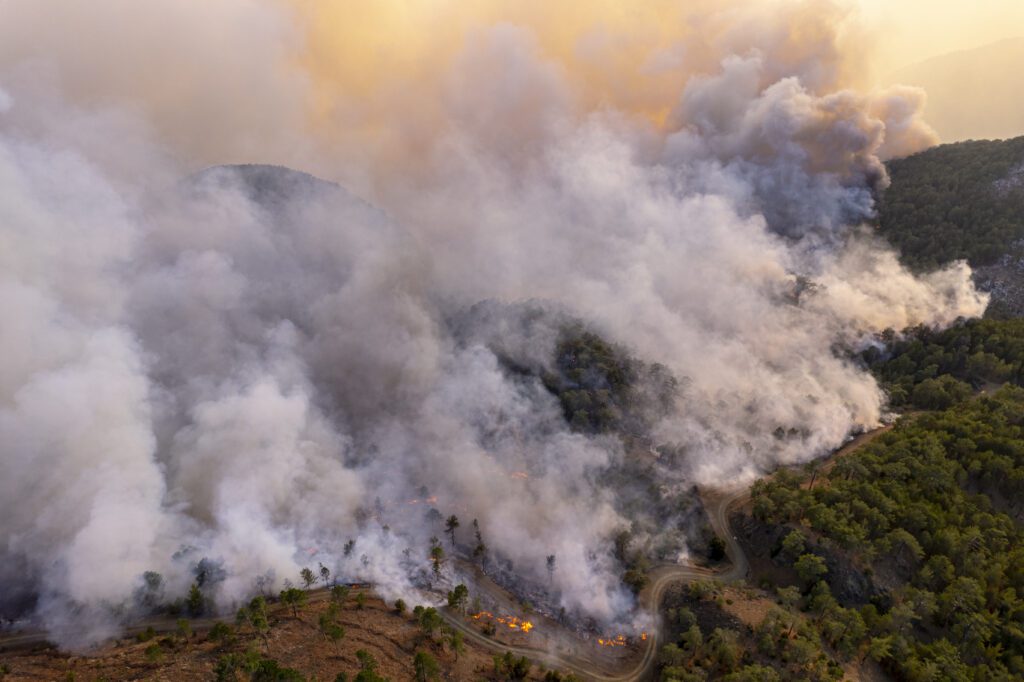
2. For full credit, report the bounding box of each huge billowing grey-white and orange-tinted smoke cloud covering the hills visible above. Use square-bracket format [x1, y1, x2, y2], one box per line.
[0, 0, 986, 646]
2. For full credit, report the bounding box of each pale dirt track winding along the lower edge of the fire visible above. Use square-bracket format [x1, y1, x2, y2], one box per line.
[0, 425, 892, 682]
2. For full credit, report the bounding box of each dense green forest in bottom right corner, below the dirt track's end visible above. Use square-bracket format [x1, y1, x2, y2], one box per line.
[753, 386, 1024, 680]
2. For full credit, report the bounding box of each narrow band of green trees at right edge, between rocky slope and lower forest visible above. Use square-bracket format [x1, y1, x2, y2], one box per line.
[861, 318, 1024, 410]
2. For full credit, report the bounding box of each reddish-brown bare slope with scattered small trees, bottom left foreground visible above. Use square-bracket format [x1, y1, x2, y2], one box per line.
[0, 591, 563, 682]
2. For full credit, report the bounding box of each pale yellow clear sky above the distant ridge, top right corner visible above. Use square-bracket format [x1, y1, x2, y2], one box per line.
[859, 0, 1024, 78]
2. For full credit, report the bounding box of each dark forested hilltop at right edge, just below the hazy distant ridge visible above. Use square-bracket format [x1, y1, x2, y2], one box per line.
[878, 137, 1024, 269]
